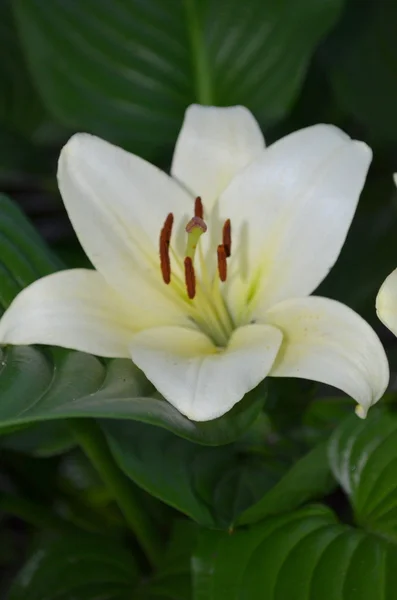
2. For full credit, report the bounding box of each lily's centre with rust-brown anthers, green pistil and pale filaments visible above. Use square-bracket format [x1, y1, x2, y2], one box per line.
[159, 197, 234, 346]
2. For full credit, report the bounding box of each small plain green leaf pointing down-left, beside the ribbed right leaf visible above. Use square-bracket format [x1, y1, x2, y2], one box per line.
[238, 444, 336, 524]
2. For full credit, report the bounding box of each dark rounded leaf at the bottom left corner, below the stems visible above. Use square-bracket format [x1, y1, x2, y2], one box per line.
[9, 534, 138, 600]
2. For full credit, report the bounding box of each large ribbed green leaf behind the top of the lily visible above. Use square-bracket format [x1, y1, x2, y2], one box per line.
[14, 0, 342, 155]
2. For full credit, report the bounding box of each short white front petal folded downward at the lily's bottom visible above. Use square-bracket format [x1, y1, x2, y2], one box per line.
[131, 325, 282, 421]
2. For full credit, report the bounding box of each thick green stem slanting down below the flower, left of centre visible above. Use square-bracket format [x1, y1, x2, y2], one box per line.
[69, 419, 162, 566]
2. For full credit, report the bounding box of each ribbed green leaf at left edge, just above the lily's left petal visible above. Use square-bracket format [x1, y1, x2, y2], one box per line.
[0, 194, 61, 314]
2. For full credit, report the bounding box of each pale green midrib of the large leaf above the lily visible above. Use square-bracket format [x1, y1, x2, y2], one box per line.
[185, 0, 213, 105]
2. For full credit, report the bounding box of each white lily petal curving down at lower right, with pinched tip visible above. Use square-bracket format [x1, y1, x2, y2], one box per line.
[266, 296, 389, 417]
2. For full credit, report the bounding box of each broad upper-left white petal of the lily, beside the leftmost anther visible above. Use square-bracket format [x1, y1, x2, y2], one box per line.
[58, 134, 193, 312]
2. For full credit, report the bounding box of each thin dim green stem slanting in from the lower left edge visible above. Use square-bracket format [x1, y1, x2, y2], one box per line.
[0, 492, 81, 533]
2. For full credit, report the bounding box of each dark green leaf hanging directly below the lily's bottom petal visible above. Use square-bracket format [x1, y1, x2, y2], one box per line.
[102, 421, 286, 528]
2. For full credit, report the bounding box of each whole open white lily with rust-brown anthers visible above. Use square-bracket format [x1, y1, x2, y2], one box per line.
[0, 106, 389, 421]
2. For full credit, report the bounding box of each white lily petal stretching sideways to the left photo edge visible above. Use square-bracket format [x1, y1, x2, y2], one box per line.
[0, 269, 136, 358]
